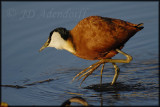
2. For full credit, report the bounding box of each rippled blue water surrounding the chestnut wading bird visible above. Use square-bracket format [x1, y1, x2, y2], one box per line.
[1, 2, 159, 106]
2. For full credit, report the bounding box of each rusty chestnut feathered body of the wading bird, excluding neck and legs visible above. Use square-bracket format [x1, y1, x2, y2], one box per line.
[70, 16, 141, 60]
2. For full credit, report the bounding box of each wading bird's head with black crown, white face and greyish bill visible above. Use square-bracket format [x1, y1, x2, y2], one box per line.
[39, 27, 69, 52]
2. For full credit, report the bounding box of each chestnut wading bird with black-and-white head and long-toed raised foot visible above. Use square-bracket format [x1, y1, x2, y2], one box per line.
[39, 16, 144, 85]
